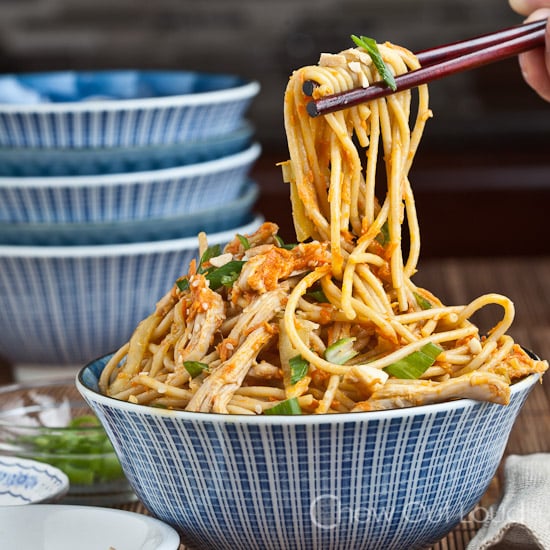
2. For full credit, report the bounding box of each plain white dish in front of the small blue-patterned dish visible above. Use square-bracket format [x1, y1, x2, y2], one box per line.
[0, 504, 180, 550]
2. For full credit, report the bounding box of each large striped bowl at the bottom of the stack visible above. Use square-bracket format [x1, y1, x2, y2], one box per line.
[0, 216, 263, 365]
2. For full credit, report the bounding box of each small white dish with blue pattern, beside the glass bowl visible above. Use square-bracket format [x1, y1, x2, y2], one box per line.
[0, 456, 69, 506]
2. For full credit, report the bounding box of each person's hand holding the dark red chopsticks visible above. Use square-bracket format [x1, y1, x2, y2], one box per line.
[509, 0, 550, 101]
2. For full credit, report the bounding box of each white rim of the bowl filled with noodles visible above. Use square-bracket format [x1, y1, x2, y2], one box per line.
[75, 354, 541, 426]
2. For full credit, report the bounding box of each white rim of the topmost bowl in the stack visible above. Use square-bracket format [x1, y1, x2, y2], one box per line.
[0, 70, 260, 115]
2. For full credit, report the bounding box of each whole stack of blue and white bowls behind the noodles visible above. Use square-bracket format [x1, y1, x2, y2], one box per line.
[0, 70, 262, 365]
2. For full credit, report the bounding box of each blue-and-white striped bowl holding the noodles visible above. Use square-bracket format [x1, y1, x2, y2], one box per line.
[77, 356, 538, 550]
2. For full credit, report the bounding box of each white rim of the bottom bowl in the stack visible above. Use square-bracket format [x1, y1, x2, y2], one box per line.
[0, 214, 264, 260]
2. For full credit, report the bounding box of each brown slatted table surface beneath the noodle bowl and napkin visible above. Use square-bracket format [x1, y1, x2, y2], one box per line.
[0, 256, 550, 550]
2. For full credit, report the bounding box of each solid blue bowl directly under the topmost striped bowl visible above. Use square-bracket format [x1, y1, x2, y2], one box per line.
[0, 121, 253, 178]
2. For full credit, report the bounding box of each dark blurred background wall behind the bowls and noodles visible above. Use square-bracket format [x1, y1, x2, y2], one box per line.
[0, 0, 550, 254]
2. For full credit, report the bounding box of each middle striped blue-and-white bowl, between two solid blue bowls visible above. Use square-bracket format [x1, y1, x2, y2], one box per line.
[0, 143, 261, 223]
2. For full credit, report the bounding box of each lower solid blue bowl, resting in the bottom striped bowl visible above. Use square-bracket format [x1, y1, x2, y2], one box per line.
[0, 182, 259, 246]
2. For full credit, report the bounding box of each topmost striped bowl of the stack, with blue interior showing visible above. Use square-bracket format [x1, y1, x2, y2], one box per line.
[0, 70, 259, 148]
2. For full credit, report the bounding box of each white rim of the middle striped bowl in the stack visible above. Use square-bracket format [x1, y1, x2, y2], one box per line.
[0, 141, 262, 191]
